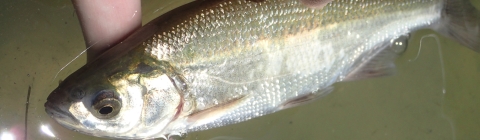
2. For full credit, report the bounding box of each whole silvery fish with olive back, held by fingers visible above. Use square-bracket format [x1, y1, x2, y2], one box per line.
[45, 0, 480, 139]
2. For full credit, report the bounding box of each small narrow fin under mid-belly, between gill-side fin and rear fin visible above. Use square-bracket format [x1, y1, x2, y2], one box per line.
[276, 87, 333, 111]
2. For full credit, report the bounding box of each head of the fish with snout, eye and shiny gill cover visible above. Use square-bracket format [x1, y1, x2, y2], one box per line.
[45, 55, 182, 138]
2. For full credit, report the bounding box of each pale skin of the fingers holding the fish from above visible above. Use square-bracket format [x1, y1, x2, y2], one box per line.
[72, 0, 333, 62]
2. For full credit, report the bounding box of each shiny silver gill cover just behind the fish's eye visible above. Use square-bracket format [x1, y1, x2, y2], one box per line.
[110, 58, 185, 137]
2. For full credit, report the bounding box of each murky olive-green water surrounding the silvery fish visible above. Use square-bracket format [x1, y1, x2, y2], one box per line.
[0, 0, 480, 140]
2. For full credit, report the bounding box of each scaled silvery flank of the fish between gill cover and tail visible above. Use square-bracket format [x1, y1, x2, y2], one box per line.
[142, 0, 442, 131]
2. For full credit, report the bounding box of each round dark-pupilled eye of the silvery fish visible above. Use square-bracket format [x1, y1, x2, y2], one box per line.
[92, 90, 122, 119]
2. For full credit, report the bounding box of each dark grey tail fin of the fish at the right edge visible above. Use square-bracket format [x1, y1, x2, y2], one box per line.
[437, 0, 480, 53]
